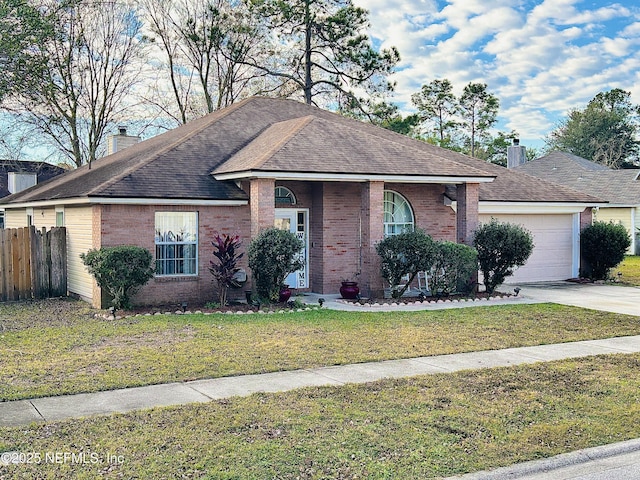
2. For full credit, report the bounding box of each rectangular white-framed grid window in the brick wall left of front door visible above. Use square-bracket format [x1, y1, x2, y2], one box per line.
[154, 210, 199, 278]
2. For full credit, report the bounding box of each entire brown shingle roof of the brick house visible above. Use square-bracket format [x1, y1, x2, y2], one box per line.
[0, 97, 597, 203]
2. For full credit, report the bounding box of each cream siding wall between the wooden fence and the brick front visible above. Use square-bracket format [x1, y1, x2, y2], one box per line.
[65, 207, 93, 301]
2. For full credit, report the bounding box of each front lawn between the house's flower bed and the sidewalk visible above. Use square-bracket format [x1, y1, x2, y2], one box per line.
[0, 300, 640, 401]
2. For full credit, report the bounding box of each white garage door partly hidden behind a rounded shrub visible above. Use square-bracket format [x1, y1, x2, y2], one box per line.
[480, 214, 577, 283]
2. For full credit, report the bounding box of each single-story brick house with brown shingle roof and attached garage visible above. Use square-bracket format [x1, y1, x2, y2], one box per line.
[4, 97, 599, 305]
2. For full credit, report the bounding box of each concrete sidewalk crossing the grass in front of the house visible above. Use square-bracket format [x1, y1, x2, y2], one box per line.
[0, 335, 640, 427]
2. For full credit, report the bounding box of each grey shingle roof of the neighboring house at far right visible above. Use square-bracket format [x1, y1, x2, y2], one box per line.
[516, 152, 640, 205]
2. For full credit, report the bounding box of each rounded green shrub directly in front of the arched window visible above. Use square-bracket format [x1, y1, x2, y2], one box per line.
[376, 230, 435, 298]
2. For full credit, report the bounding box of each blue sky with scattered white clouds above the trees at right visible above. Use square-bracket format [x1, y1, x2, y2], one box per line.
[354, 0, 640, 147]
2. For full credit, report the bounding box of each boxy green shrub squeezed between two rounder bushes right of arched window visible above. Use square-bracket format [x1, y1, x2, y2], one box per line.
[429, 241, 478, 295]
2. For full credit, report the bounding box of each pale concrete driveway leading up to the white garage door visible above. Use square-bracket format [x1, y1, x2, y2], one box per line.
[519, 282, 640, 316]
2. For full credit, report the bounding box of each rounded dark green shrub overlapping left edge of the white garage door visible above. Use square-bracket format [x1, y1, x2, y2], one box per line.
[473, 218, 533, 293]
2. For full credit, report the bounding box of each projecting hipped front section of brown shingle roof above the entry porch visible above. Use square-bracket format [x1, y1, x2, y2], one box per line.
[213, 115, 492, 179]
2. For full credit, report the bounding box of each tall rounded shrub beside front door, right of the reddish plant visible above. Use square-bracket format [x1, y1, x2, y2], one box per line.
[248, 227, 304, 303]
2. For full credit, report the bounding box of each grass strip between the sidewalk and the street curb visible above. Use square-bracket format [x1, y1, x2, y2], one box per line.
[0, 355, 640, 480]
